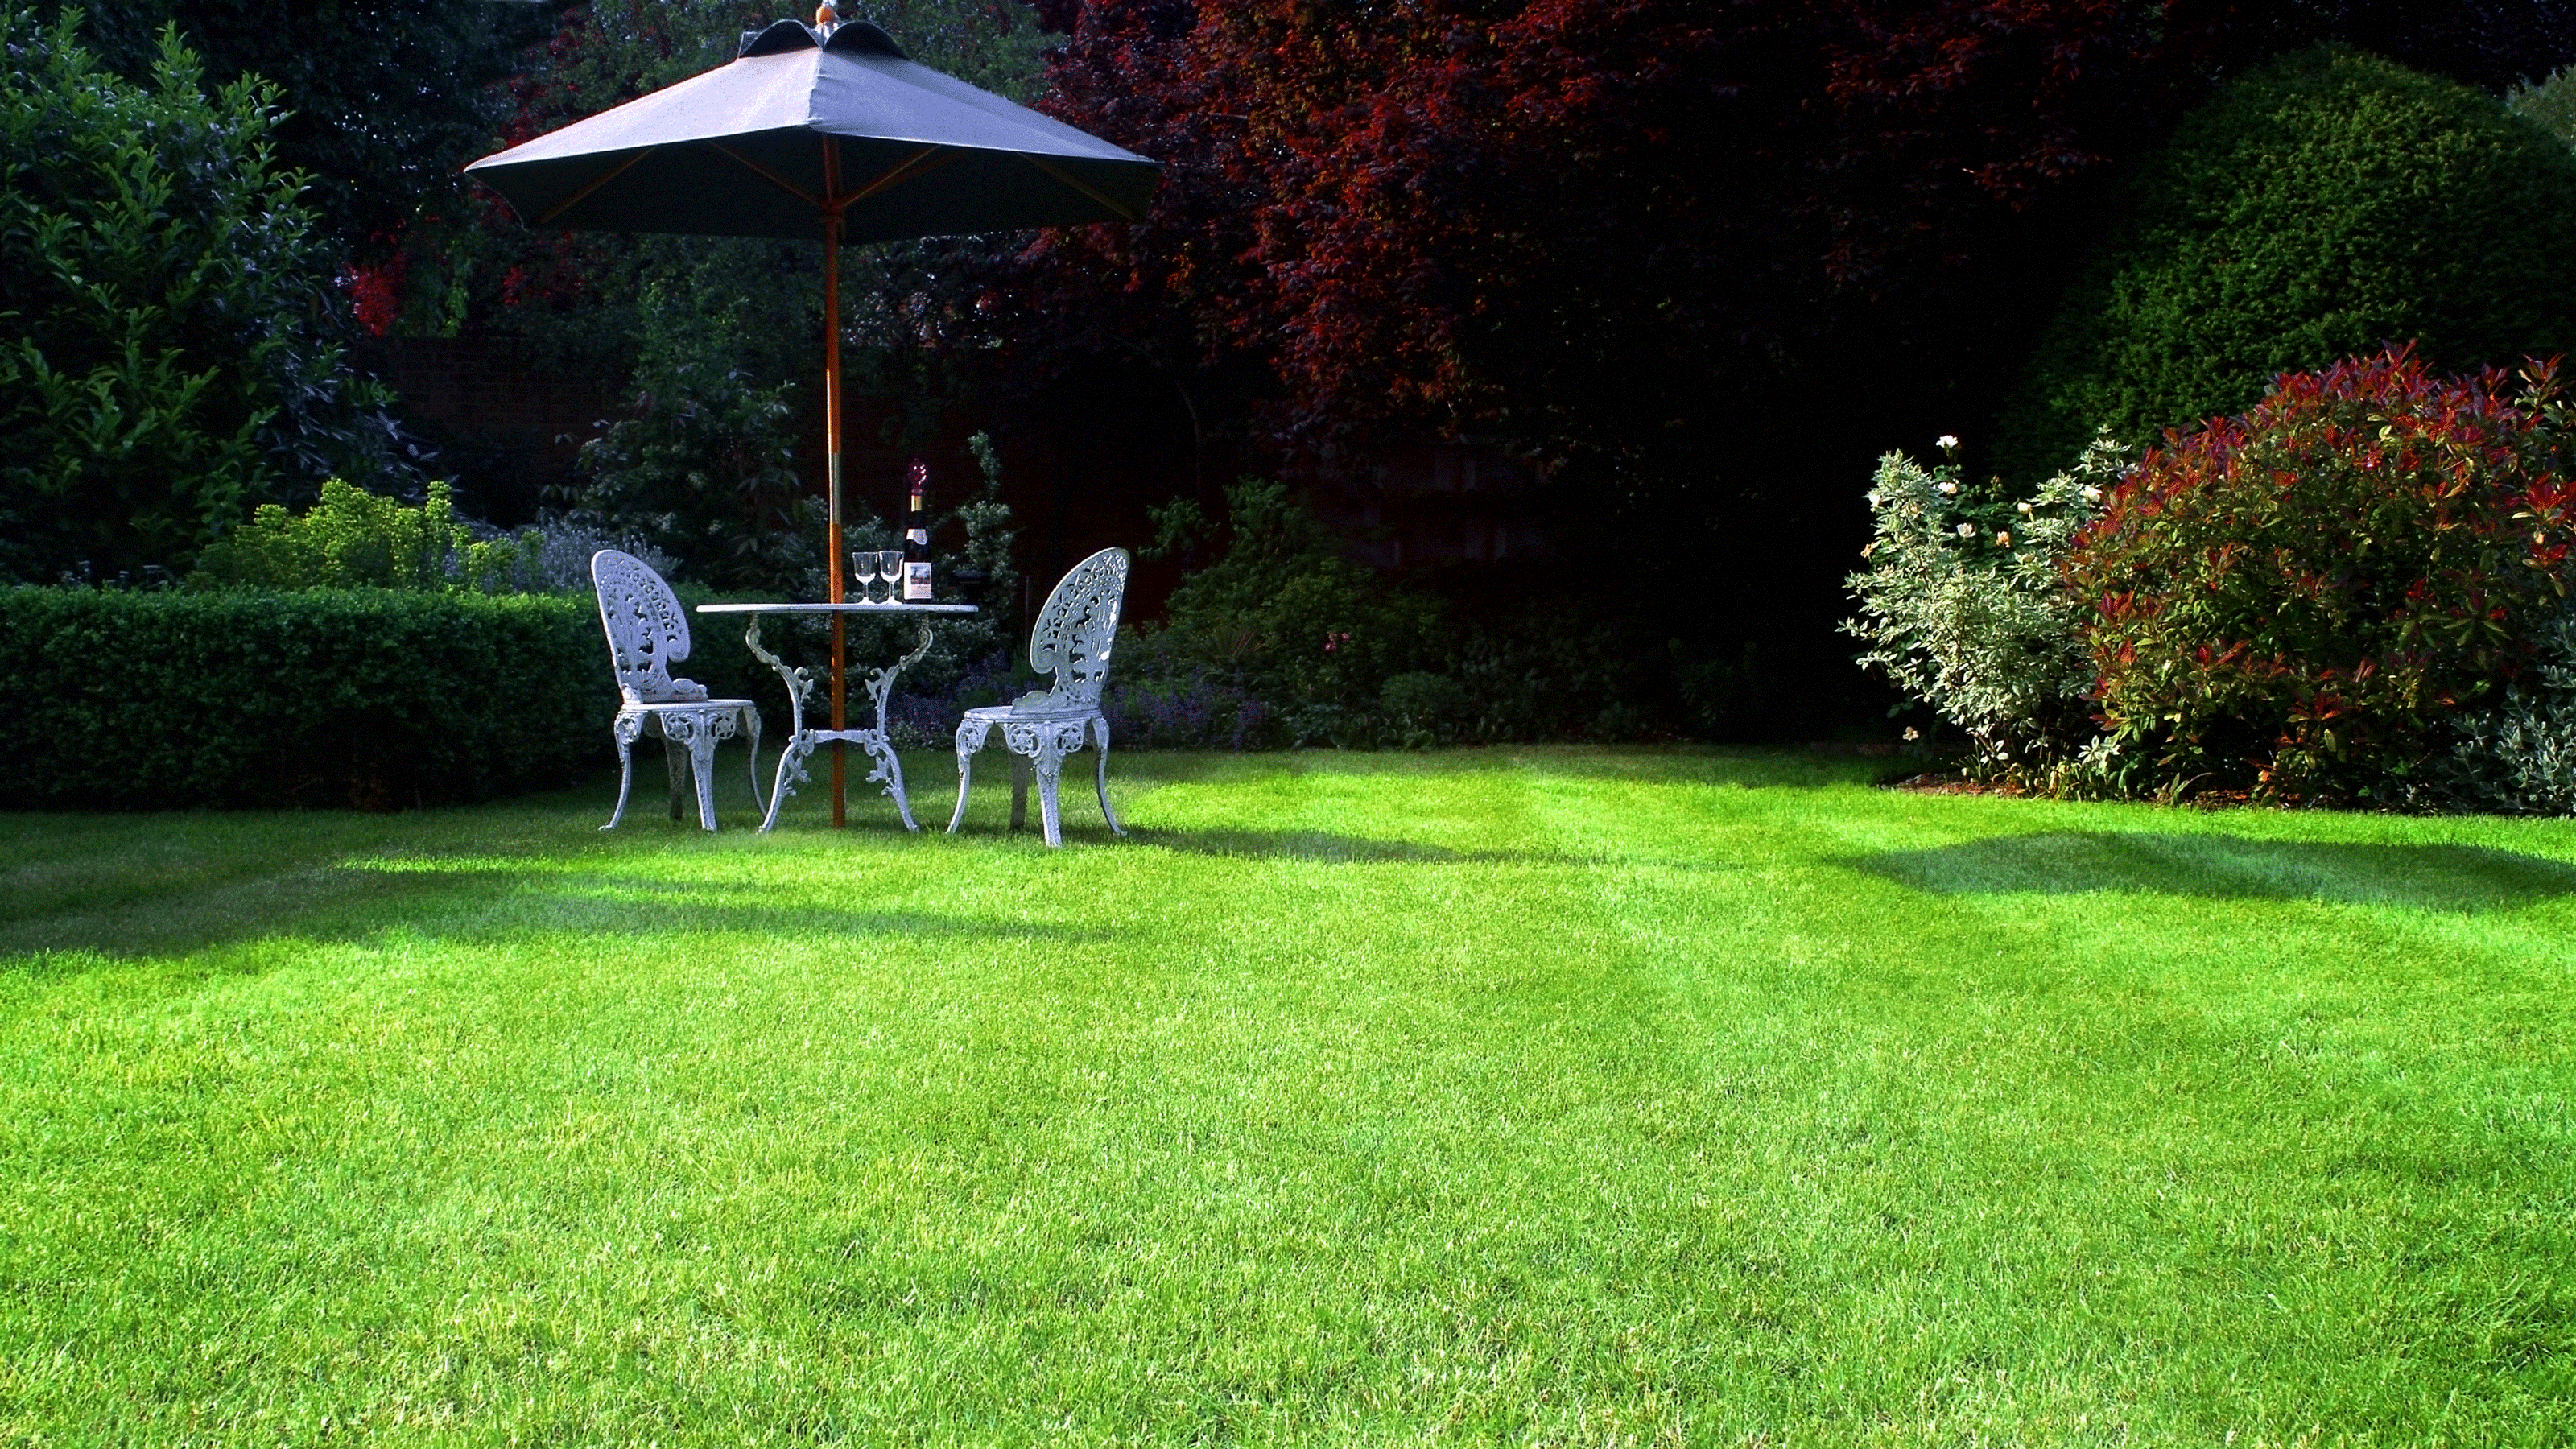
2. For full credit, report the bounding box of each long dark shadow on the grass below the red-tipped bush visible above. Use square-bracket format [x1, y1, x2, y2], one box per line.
[1839, 830, 2576, 910]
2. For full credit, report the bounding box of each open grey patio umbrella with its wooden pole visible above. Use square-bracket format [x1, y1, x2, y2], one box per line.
[466, 5, 1159, 825]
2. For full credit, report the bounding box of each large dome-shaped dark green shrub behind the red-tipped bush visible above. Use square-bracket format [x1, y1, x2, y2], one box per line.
[1996, 49, 2576, 480]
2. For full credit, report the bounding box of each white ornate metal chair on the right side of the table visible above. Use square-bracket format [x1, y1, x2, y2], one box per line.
[948, 549, 1125, 846]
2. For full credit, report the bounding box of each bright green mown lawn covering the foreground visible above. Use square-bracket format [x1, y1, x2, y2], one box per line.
[0, 750, 2576, 1447]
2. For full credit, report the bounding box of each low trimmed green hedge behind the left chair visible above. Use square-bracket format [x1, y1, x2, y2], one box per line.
[0, 588, 628, 810]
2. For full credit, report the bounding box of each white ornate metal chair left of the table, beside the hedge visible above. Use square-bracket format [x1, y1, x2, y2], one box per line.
[590, 549, 760, 830]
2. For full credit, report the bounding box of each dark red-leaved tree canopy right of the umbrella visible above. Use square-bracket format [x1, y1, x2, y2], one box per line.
[1013, 0, 2166, 469]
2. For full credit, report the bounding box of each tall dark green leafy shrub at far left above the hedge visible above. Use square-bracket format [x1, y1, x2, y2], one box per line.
[0, 0, 407, 580]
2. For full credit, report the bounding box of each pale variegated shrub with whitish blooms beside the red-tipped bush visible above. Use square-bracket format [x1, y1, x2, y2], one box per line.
[1844, 438, 2123, 776]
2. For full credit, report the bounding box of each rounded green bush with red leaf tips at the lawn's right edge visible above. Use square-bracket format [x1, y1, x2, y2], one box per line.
[2066, 348, 2576, 799]
